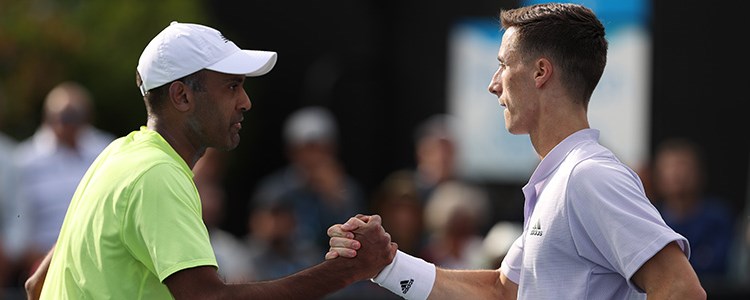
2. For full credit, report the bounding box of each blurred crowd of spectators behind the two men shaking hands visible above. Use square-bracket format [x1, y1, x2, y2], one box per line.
[0, 82, 750, 299]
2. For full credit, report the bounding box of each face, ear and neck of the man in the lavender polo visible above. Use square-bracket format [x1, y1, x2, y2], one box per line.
[488, 27, 589, 158]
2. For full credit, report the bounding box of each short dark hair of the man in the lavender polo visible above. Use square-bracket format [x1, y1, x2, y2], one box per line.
[500, 3, 608, 106]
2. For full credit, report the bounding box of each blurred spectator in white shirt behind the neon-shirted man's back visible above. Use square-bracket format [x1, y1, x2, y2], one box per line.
[8, 82, 114, 278]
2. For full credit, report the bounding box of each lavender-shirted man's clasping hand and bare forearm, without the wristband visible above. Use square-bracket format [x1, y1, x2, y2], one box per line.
[326, 215, 518, 300]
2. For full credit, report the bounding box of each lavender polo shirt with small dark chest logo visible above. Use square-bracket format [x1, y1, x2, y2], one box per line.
[500, 129, 690, 300]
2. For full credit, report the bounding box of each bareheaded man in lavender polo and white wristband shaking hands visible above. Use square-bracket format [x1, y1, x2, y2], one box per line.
[326, 3, 706, 299]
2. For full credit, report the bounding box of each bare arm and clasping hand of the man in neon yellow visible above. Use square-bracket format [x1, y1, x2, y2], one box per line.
[164, 217, 397, 299]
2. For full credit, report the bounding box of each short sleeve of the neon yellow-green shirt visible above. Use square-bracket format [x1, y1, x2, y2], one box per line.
[123, 164, 217, 281]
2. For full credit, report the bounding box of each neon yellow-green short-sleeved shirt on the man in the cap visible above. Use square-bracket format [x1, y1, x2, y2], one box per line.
[42, 127, 217, 300]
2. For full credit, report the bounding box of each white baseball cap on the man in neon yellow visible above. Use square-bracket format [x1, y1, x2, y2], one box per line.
[137, 21, 276, 96]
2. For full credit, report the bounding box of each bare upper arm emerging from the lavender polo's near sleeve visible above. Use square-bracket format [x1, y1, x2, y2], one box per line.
[632, 242, 706, 299]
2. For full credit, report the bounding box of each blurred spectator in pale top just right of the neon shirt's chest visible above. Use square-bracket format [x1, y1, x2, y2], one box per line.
[193, 148, 253, 282]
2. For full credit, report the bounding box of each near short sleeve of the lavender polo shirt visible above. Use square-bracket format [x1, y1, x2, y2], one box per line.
[566, 159, 690, 289]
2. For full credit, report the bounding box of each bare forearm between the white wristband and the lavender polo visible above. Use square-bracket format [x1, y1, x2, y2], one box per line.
[428, 268, 517, 300]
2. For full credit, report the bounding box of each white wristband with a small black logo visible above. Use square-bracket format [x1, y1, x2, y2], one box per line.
[370, 250, 435, 300]
